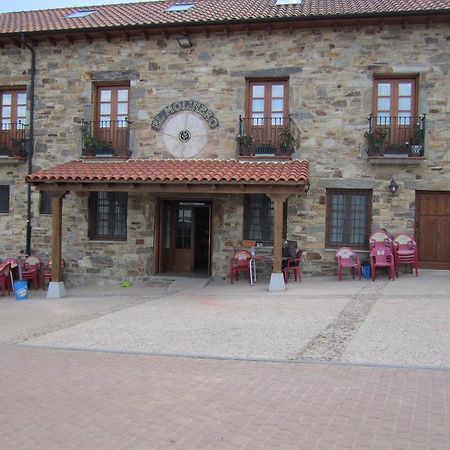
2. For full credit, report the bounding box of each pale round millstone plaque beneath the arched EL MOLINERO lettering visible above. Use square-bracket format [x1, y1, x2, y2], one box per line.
[161, 111, 208, 159]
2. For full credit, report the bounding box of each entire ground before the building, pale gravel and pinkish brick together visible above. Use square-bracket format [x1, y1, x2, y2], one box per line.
[0, 271, 450, 450]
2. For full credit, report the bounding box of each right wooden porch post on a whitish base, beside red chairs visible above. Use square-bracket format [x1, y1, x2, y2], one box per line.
[266, 194, 288, 291]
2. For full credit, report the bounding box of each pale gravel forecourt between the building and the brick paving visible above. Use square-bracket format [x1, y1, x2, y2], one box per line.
[0, 270, 450, 368]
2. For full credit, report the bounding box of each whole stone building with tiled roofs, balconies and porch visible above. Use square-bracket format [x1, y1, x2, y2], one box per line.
[0, 0, 450, 294]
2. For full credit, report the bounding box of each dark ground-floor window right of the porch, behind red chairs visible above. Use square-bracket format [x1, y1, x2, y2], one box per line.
[326, 189, 372, 250]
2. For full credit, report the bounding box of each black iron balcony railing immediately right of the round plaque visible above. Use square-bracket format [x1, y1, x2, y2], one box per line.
[236, 116, 297, 157]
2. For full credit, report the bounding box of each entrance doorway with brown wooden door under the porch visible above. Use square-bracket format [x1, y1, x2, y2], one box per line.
[157, 200, 211, 275]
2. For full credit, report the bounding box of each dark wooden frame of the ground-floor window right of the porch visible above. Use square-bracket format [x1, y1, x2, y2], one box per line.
[325, 188, 373, 250]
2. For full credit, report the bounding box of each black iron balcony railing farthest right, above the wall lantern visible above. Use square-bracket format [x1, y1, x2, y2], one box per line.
[364, 114, 425, 157]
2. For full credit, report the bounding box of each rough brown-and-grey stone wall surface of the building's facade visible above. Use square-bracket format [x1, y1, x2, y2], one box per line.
[0, 24, 450, 283]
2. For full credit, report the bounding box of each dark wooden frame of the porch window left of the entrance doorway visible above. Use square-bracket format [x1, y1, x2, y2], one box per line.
[88, 191, 128, 241]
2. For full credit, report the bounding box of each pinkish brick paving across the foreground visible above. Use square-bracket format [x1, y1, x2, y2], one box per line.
[0, 345, 450, 450]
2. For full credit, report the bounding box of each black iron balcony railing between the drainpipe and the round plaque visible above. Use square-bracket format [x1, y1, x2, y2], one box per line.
[81, 120, 131, 158]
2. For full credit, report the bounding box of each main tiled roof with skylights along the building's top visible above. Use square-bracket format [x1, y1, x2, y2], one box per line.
[0, 0, 450, 34]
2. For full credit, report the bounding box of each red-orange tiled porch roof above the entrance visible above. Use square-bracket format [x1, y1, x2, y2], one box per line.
[27, 159, 308, 184]
